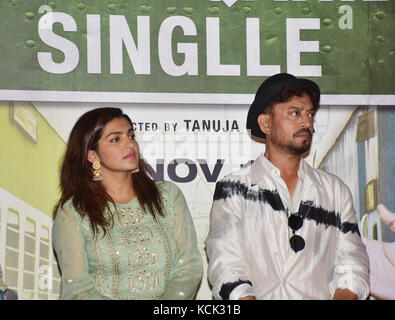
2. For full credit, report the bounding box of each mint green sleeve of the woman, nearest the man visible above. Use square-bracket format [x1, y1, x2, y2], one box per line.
[161, 184, 203, 300]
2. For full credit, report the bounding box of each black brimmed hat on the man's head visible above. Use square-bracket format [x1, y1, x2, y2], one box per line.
[247, 73, 320, 138]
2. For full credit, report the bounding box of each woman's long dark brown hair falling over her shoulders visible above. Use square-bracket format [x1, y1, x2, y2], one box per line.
[54, 108, 164, 235]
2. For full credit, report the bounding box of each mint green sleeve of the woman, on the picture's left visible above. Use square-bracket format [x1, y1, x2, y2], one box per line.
[52, 205, 109, 300]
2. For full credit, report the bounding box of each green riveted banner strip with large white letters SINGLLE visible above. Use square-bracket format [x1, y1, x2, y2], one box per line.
[0, 0, 395, 103]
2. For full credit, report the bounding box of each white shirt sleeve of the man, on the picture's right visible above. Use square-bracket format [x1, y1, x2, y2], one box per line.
[329, 186, 369, 299]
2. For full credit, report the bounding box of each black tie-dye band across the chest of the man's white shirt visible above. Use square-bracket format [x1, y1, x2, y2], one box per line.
[214, 180, 360, 235]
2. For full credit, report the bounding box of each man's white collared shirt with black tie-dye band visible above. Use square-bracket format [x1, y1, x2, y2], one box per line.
[205, 155, 369, 299]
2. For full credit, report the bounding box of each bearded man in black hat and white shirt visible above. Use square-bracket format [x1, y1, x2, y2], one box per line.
[205, 74, 369, 299]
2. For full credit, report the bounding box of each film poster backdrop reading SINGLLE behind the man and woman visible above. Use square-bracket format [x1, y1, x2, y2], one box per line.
[0, 0, 395, 300]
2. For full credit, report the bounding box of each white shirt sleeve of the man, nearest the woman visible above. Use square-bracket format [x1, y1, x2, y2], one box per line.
[205, 181, 255, 300]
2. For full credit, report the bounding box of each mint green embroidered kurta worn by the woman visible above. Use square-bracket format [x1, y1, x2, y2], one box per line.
[53, 182, 202, 299]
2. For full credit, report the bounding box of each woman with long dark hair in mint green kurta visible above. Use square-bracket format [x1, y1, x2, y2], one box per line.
[53, 108, 202, 299]
